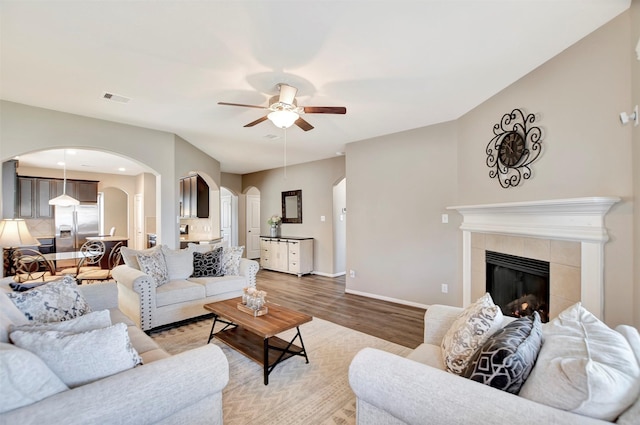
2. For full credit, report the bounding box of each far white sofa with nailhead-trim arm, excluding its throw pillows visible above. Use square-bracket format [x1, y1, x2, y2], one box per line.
[112, 244, 259, 331]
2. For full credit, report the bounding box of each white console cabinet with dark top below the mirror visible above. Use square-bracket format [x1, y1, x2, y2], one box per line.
[260, 236, 313, 277]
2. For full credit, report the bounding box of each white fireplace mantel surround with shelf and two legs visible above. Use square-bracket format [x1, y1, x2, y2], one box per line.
[447, 197, 620, 318]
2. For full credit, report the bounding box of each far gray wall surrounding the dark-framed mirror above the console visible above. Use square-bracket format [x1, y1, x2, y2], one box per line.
[242, 156, 345, 275]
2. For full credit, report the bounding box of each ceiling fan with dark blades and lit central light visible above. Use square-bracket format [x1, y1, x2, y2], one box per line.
[218, 83, 347, 131]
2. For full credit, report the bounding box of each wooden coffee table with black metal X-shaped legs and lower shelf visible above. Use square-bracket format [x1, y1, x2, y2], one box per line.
[204, 297, 313, 385]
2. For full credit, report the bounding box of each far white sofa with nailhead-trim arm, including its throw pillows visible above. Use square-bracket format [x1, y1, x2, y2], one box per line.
[112, 243, 259, 331]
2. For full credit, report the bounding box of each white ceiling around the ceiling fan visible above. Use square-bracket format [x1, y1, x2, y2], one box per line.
[0, 0, 630, 174]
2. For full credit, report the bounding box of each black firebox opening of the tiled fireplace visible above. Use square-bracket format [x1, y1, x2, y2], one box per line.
[485, 251, 549, 322]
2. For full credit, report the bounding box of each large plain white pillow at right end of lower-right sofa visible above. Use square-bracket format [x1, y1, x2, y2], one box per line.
[520, 303, 640, 421]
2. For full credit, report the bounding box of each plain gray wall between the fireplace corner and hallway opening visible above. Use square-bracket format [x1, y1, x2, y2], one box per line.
[346, 123, 462, 305]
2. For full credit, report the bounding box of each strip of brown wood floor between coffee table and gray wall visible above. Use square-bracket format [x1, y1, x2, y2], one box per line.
[256, 269, 425, 348]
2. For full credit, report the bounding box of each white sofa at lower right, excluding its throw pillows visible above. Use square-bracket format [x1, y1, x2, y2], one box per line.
[349, 305, 640, 425]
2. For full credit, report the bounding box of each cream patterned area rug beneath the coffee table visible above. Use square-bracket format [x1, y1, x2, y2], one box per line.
[151, 318, 411, 425]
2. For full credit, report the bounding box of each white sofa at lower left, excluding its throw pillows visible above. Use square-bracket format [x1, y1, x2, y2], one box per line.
[0, 278, 229, 425]
